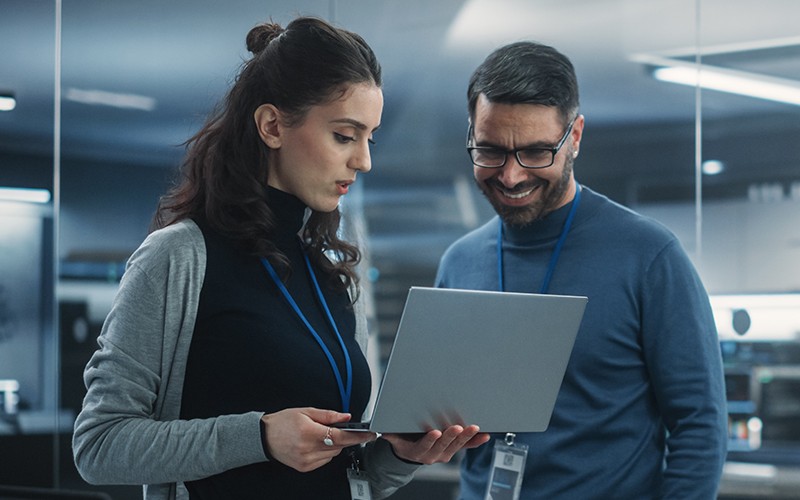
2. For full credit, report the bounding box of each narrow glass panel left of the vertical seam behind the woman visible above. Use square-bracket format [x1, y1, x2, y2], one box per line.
[0, 0, 59, 485]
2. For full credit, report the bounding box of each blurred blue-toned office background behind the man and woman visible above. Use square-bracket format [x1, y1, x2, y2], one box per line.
[0, 0, 800, 499]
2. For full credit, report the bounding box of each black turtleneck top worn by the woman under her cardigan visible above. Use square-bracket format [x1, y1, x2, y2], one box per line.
[181, 188, 370, 500]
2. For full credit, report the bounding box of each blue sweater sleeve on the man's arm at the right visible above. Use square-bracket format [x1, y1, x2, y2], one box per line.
[642, 241, 727, 499]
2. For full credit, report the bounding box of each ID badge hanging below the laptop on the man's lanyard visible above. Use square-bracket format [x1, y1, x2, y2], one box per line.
[484, 434, 528, 500]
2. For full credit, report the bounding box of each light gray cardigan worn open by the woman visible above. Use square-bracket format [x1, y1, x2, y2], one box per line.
[73, 220, 418, 500]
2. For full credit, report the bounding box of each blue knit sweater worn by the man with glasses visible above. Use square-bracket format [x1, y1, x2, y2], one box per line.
[436, 187, 727, 500]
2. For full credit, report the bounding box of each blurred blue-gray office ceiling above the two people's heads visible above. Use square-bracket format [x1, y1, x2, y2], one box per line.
[0, 0, 800, 166]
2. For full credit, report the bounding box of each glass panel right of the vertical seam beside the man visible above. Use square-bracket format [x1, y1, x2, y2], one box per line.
[699, 0, 800, 497]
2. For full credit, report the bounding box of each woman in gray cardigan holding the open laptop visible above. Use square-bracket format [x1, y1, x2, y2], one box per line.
[73, 18, 488, 499]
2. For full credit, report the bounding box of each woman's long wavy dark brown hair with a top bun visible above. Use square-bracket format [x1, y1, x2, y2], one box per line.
[151, 17, 382, 288]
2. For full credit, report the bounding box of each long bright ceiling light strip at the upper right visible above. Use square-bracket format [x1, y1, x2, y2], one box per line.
[653, 66, 800, 106]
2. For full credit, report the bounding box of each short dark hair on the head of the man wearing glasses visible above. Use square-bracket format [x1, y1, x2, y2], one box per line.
[467, 42, 579, 126]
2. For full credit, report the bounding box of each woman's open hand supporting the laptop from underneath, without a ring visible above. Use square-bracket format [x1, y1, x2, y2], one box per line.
[382, 425, 489, 465]
